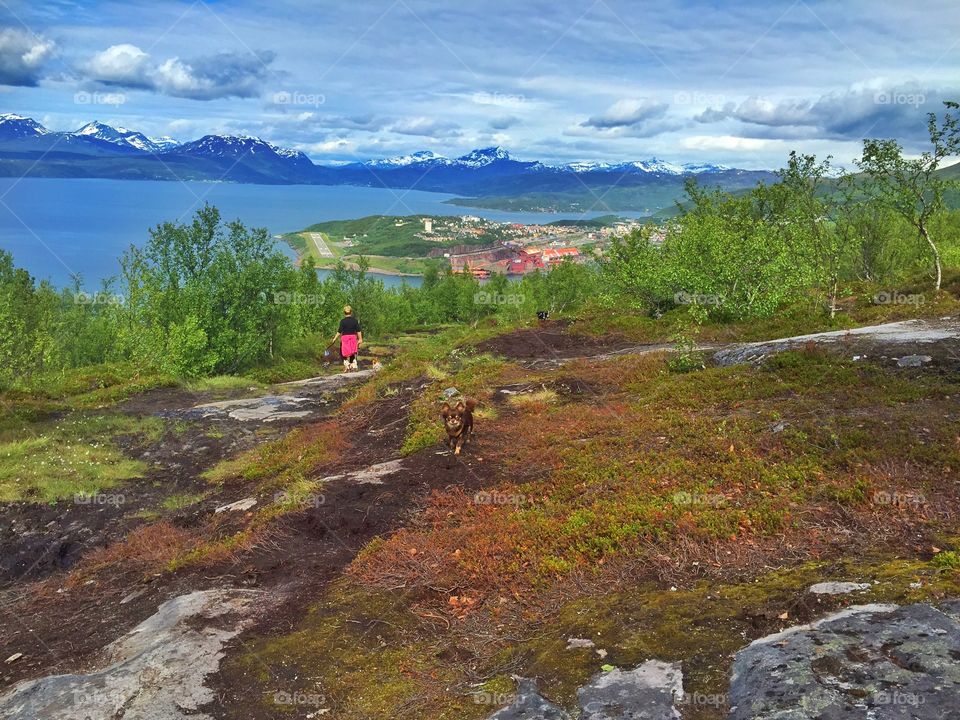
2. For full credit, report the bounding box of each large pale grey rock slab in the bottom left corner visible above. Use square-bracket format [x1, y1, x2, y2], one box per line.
[0, 590, 263, 720]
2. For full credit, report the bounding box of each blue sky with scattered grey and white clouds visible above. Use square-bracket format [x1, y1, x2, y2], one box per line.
[0, 0, 960, 168]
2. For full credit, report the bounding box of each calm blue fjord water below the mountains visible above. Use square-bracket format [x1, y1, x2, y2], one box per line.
[0, 178, 640, 288]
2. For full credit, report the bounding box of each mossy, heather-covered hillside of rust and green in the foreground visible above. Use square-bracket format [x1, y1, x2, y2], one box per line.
[0, 296, 960, 720]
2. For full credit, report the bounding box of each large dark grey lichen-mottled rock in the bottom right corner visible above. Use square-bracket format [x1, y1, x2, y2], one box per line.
[729, 604, 960, 720]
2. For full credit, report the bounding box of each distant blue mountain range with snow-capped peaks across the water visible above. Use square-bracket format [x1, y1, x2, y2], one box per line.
[0, 113, 774, 209]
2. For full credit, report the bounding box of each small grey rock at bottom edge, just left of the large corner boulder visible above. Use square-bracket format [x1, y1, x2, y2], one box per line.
[577, 660, 683, 720]
